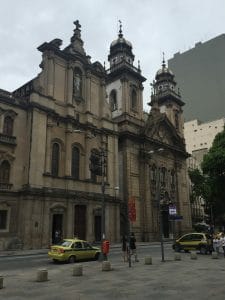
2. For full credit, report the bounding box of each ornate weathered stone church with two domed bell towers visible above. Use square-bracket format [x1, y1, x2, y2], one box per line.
[0, 21, 191, 249]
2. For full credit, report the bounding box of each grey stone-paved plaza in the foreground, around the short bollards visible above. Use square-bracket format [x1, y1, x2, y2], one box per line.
[0, 245, 225, 300]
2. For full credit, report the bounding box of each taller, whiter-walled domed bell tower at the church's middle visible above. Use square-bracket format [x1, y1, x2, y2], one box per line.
[106, 21, 146, 120]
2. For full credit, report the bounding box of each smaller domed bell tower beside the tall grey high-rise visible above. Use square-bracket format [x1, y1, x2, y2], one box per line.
[149, 55, 184, 137]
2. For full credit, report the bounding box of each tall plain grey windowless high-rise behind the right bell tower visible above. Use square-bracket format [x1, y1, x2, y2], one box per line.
[168, 34, 225, 122]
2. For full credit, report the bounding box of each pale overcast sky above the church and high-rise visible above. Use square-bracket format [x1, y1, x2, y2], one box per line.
[0, 0, 225, 110]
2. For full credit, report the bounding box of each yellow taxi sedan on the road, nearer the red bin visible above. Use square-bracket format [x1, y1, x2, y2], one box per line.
[48, 239, 101, 263]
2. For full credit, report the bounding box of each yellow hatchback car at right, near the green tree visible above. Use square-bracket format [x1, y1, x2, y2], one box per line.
[172, 232, 212, 254]
